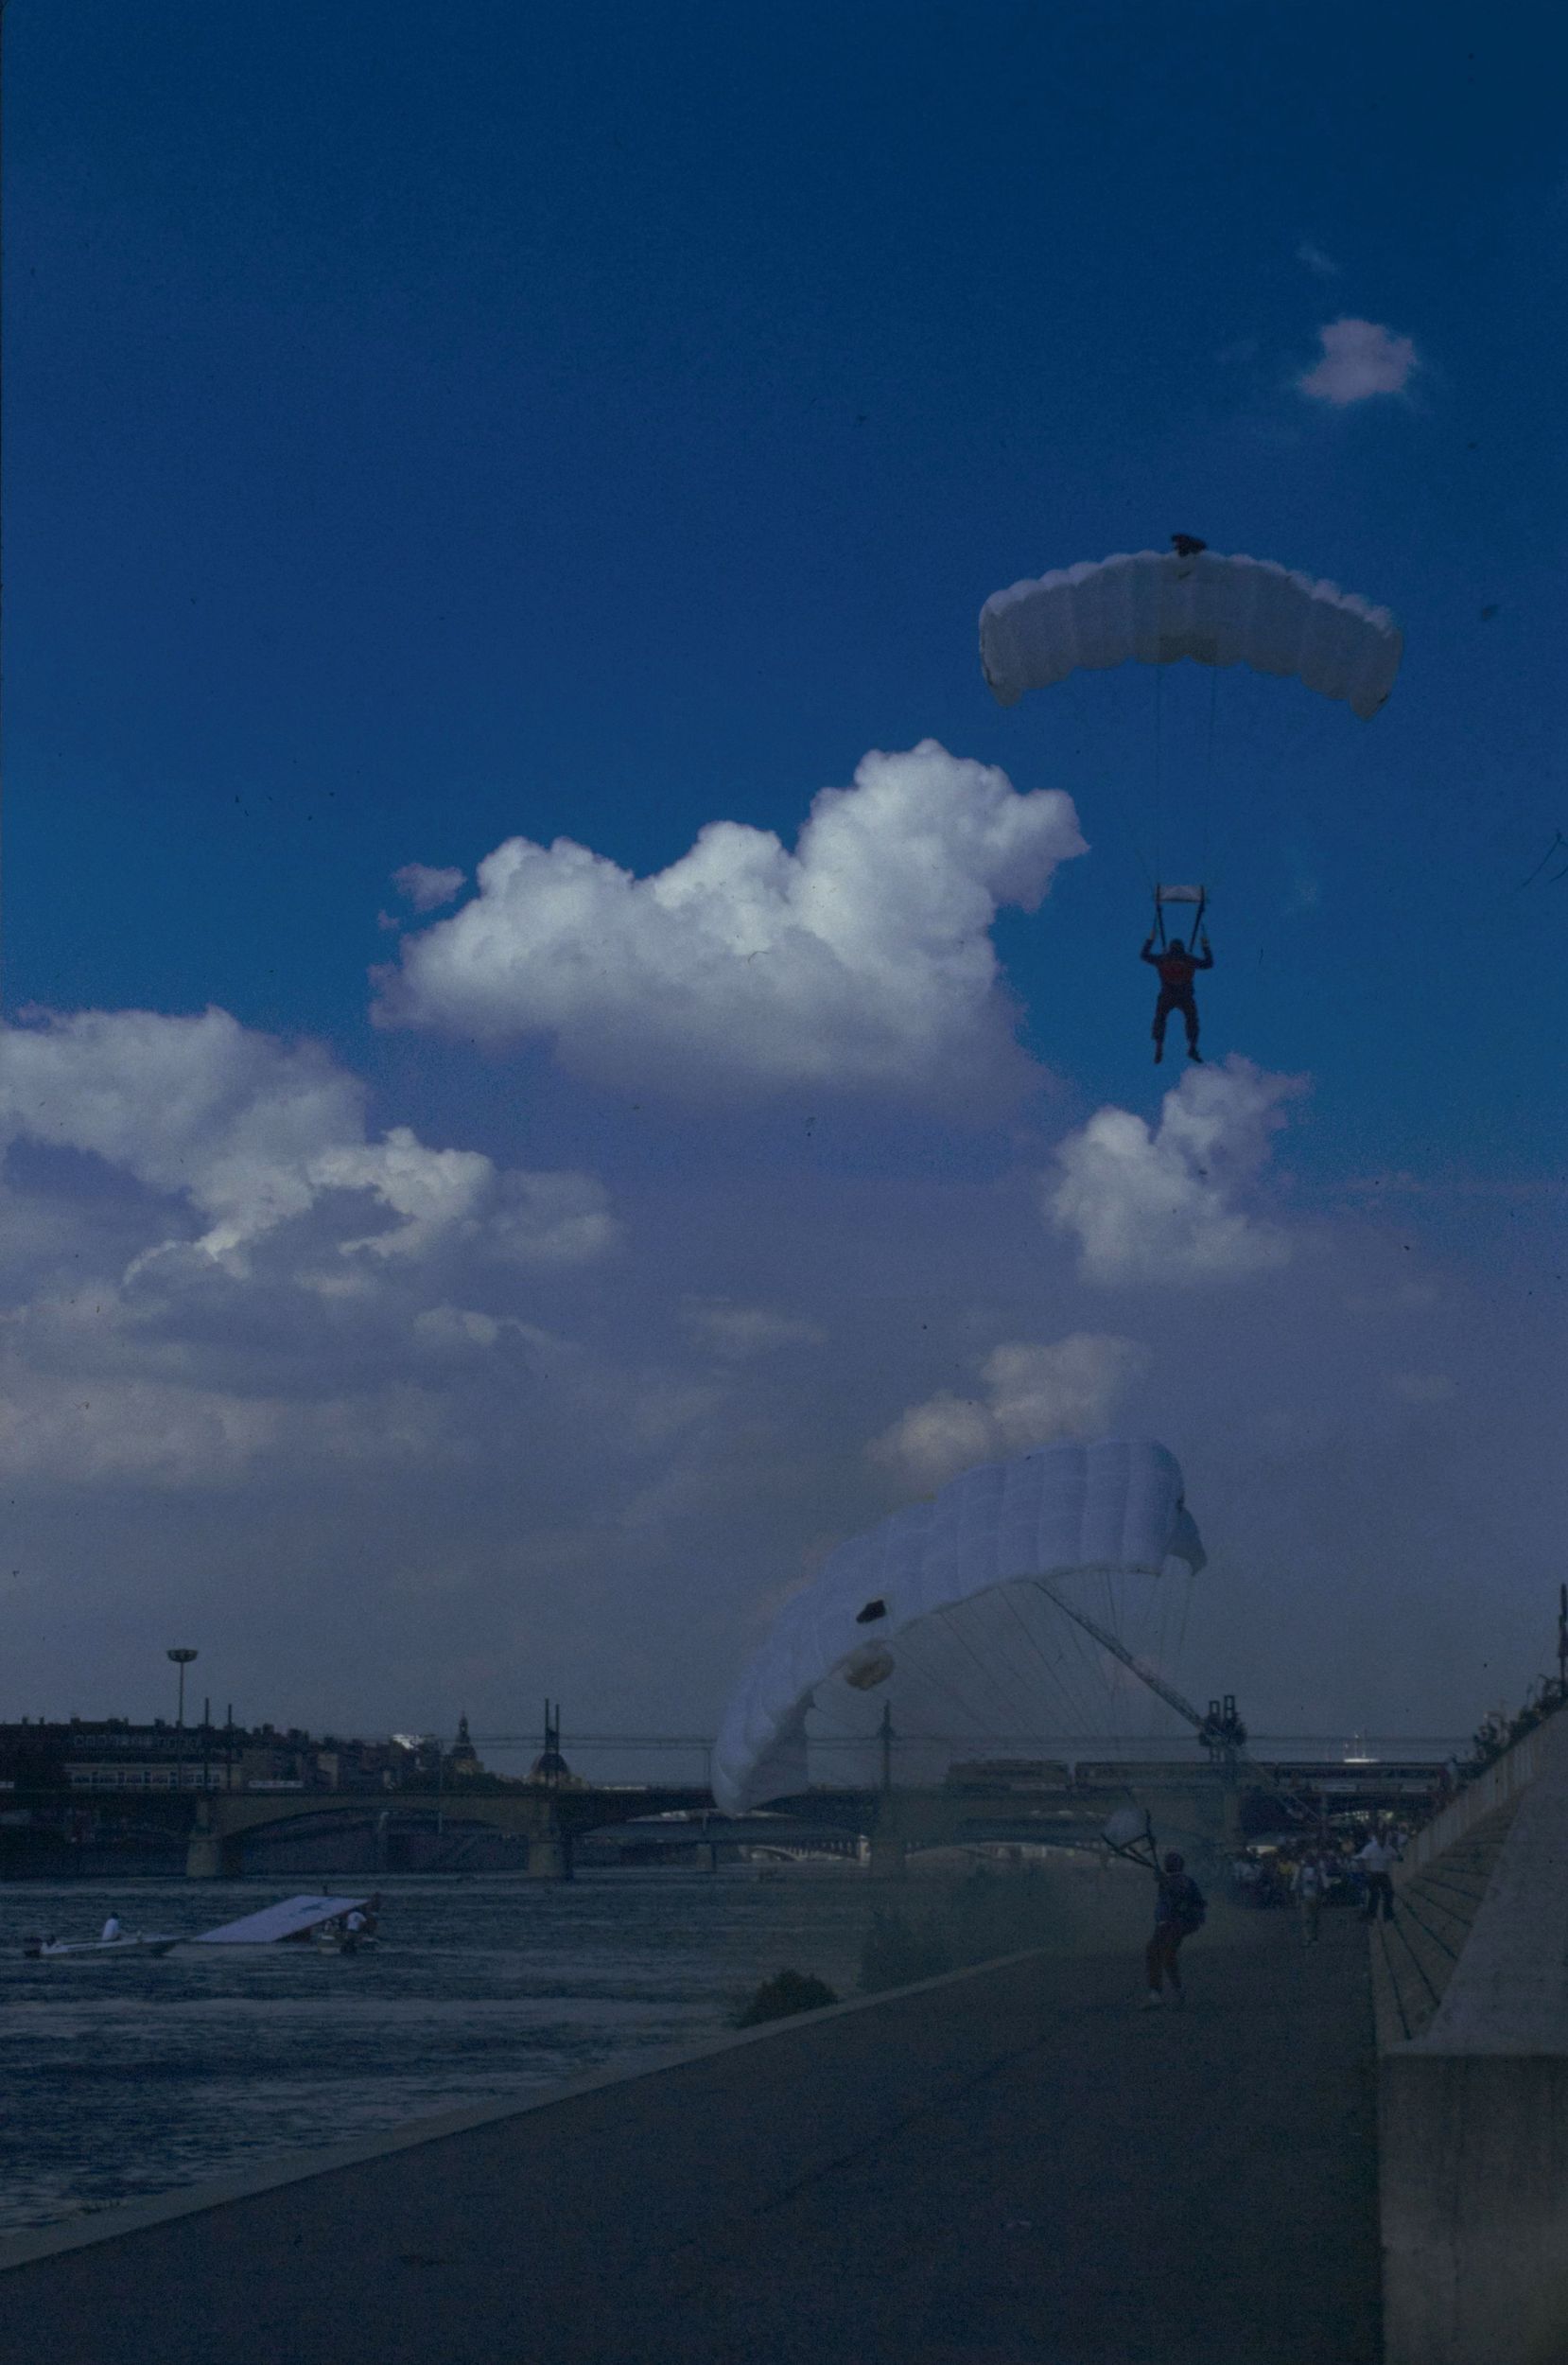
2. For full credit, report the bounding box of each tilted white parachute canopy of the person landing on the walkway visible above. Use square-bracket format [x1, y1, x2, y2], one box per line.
[714, 1438, 1204, 1814]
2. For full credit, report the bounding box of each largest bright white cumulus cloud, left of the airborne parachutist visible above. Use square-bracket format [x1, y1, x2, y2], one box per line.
[376, 741, 1086, 1100]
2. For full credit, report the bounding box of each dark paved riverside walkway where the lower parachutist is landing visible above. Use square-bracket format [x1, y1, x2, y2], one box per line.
[0, 1914, 1379, 2365]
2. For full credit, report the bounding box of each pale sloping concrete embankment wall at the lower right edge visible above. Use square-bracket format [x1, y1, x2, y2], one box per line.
[1374, 1712, 1568, 2365]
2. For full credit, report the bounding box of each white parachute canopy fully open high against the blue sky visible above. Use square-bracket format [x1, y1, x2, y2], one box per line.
[979, 552, 1404, 722]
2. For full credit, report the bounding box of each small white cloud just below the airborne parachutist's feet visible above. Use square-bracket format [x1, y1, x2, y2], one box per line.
[1045, 1058, 1305, 1285]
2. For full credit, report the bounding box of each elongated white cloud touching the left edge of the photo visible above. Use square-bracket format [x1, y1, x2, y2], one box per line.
[0, 1010, 615, 1263]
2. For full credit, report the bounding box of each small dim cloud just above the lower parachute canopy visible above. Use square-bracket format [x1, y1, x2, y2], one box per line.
[870, 1332, 1149, 1485]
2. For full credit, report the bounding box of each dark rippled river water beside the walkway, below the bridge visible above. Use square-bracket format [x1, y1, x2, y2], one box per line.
[0, 1866, 870, 2231]
